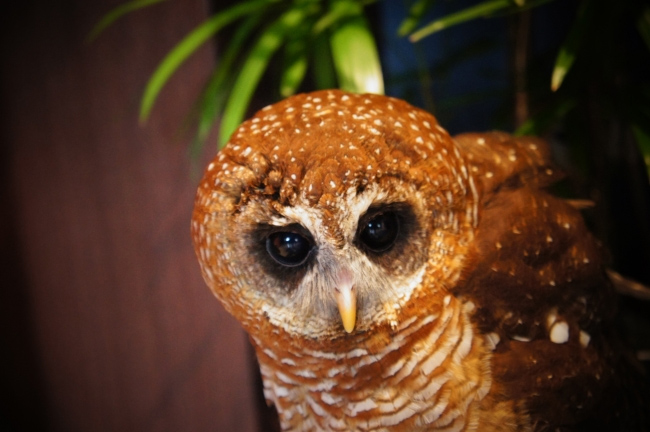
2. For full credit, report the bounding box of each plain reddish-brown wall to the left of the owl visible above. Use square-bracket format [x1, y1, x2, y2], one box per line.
[0, 0, 257, 431]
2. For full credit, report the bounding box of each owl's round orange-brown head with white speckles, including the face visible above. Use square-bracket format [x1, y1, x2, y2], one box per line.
[192, 91, 477, 338]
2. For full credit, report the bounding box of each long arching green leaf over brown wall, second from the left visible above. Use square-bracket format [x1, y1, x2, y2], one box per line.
[140, 0, 273, 122]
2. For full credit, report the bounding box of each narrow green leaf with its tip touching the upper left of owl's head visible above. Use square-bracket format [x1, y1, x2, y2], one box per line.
[219, 8, 305, 146]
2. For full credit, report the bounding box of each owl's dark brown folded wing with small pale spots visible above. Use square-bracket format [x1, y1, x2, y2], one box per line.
[455, 133, 647, 430]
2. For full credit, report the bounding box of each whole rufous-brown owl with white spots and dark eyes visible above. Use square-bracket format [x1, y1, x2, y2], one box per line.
[191, 90, 650, 431]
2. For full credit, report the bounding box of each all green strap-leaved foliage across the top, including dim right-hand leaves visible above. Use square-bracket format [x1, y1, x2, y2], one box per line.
[89, 0, 650, 181]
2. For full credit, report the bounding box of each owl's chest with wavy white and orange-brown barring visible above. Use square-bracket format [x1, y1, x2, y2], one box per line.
[257, 300, 491, 431]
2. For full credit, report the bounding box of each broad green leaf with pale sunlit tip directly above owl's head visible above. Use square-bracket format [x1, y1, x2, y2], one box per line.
[330, 7, 384, 94]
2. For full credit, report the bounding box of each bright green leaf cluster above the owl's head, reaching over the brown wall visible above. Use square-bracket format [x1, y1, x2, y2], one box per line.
[91, 0, 384, 145]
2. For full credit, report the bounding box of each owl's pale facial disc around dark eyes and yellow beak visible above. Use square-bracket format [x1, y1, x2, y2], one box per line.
[241, 189, 428, 336]
